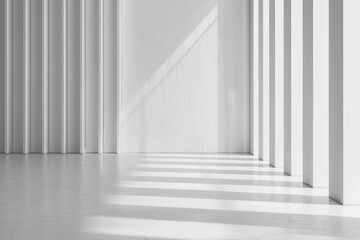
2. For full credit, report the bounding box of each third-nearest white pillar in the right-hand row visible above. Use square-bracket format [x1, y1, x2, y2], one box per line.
[284, 0, 303, 176]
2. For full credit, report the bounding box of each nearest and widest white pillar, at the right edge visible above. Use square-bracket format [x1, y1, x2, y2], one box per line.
[329, 0, 360, 204]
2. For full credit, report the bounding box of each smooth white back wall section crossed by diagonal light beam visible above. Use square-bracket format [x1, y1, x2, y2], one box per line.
[122, 0, 249, 152]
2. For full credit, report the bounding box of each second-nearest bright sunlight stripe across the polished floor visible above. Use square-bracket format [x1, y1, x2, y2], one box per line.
[105, 195, 360, 218]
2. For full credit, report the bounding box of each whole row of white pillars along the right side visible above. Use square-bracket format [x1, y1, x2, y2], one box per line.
[251, 0, 360, 204]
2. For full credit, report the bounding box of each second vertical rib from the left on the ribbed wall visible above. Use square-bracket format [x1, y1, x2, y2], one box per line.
[23, 0, 31, 153]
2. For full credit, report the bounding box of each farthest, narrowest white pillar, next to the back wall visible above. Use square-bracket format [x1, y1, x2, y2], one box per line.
[250, 0, 259, 156]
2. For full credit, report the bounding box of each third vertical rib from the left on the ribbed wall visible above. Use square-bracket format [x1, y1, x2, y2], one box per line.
[42, 0, 49, 153]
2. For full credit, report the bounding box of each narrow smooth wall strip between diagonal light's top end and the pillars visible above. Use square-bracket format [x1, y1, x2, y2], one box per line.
[218, 0, 250, 152]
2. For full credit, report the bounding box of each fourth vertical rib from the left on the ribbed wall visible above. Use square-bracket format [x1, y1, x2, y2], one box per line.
[61, 0, 68, 153]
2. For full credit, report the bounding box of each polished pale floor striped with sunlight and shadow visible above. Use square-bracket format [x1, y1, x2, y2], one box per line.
[0, 154, 360, 240]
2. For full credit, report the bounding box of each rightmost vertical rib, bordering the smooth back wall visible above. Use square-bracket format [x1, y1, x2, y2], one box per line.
[116, 0, 122, 153]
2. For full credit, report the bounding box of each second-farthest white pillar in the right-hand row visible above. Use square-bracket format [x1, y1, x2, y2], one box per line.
[259, 0, 270, 161]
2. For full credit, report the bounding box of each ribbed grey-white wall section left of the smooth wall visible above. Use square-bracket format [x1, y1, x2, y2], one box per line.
[0, 0, 121, 153]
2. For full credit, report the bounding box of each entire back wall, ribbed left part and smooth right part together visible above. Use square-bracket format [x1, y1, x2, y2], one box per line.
[0, 0, 249, 153]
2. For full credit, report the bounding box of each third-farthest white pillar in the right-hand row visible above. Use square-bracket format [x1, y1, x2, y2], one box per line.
[270, 0, 284, 167]
